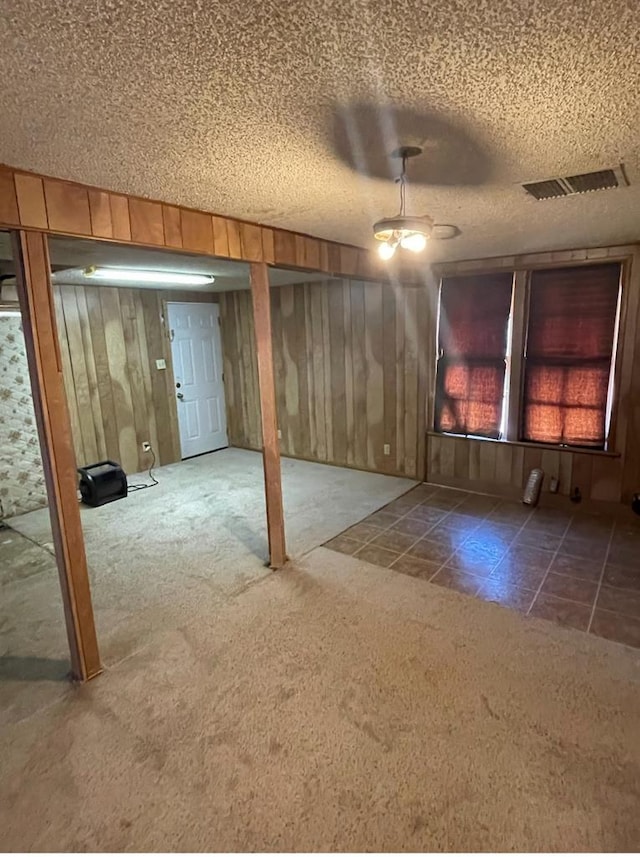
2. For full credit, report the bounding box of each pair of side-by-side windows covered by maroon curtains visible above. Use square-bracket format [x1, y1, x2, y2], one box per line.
[435, 263, 621, 449]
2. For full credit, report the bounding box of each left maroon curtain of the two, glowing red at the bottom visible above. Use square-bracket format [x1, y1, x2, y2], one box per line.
[435, 273, 513, 438]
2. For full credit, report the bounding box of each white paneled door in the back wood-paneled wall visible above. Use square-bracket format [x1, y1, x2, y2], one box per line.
[167, 303, 229, 458]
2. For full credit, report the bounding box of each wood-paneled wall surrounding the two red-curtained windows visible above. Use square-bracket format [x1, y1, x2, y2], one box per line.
[427, 245, 640, 503]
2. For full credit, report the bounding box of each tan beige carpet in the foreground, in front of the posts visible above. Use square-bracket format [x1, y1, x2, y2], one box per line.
[0, 548, 640, 851]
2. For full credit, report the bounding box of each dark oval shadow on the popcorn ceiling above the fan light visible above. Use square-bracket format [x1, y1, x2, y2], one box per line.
[332, 104, 492, 185]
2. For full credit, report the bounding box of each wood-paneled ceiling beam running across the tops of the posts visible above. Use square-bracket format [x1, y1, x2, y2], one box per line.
[0, 165, 418, 281]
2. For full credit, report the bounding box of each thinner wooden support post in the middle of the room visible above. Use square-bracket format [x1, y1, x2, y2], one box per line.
[250, 262, 287, 568]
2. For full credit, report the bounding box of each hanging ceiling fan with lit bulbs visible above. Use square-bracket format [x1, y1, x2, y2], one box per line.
[373, 146, 460, 259]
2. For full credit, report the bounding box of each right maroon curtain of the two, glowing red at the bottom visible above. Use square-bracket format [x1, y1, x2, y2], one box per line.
[522, 265, 620, 449]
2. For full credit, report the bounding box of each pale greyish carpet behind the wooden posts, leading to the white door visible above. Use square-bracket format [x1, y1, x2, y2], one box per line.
[0, 449, 415, 727]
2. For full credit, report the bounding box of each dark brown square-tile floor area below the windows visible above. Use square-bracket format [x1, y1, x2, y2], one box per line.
[325, 484, 640, 648]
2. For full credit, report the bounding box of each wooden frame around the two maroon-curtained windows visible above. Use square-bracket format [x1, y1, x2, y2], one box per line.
[430, 252, 637, 456]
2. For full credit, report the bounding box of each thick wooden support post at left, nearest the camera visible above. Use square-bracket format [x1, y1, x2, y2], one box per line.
[13, 232, 102, 681]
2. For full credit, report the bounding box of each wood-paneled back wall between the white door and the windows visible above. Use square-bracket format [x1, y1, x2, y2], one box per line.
[220, 280, 435, 478]
